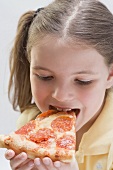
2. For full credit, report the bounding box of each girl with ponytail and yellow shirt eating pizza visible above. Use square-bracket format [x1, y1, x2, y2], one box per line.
[5, 0, 113, 170]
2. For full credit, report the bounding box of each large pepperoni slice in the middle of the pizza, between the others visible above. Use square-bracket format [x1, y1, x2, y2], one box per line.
[29, 128, 55, 143]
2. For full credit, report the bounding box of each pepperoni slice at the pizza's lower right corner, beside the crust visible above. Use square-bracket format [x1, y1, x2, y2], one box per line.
[56, 135, 76, 150]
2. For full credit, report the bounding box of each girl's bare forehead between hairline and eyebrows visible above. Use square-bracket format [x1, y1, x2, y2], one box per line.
[31, 38, 105, 72]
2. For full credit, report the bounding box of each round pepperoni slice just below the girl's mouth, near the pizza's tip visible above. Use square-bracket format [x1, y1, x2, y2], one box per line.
[51, 116, 73, 132]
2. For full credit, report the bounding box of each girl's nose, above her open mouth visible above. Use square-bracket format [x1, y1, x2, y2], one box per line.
[52, 86, 74, 102]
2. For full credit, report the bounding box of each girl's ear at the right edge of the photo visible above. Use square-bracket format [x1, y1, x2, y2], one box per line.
[106, 64, 113, 89]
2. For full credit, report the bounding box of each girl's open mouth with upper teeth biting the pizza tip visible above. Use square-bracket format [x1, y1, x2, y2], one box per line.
[49, 105, 80, 116]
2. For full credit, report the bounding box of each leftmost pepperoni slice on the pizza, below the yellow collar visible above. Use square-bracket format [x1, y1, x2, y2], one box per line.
[15, 120, 36, 135]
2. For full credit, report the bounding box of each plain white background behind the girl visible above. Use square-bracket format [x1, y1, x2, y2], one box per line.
[0, 0, 113, 170]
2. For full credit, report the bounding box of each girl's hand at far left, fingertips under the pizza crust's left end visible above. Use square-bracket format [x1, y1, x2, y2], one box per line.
[5, 149, 34, 170]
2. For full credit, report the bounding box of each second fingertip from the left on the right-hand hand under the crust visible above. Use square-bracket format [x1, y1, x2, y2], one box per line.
[42, 157, 56, 170]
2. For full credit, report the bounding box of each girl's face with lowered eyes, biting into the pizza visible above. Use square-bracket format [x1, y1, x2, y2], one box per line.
[30, 39, 113, 131]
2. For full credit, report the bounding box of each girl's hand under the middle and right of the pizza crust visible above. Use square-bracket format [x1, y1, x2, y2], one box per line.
[34, 157, 79, 170]
